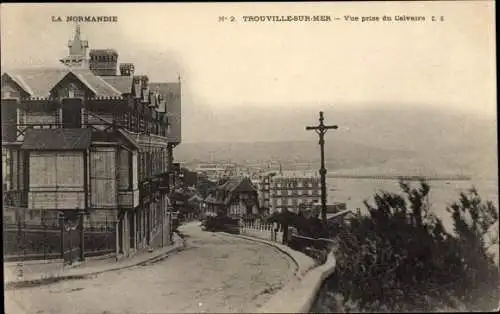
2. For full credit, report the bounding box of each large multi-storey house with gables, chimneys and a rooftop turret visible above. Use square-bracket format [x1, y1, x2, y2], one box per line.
[1, 26, 181, 255]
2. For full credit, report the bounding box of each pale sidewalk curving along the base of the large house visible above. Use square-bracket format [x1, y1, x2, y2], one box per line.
[4, 234, 185, 289]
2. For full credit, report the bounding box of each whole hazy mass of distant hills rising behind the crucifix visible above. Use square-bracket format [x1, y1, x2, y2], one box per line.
[175, 108, 498, 178]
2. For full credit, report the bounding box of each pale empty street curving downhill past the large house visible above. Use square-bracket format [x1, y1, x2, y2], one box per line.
[5, 223, 295, 314]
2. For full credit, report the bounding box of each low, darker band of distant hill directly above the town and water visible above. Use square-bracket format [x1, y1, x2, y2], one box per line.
[175, 141, 497, 178]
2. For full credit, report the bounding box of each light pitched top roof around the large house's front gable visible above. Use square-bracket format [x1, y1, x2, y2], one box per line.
[5, 67, 122, 98]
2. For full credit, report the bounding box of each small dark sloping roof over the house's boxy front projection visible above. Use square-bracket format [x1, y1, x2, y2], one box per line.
[21, 128, 92, 150]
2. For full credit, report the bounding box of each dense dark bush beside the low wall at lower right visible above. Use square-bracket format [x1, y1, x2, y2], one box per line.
[315, 181, 500, 312]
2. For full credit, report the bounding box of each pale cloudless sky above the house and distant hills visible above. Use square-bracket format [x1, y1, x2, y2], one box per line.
[1, 1, 497, 141]
